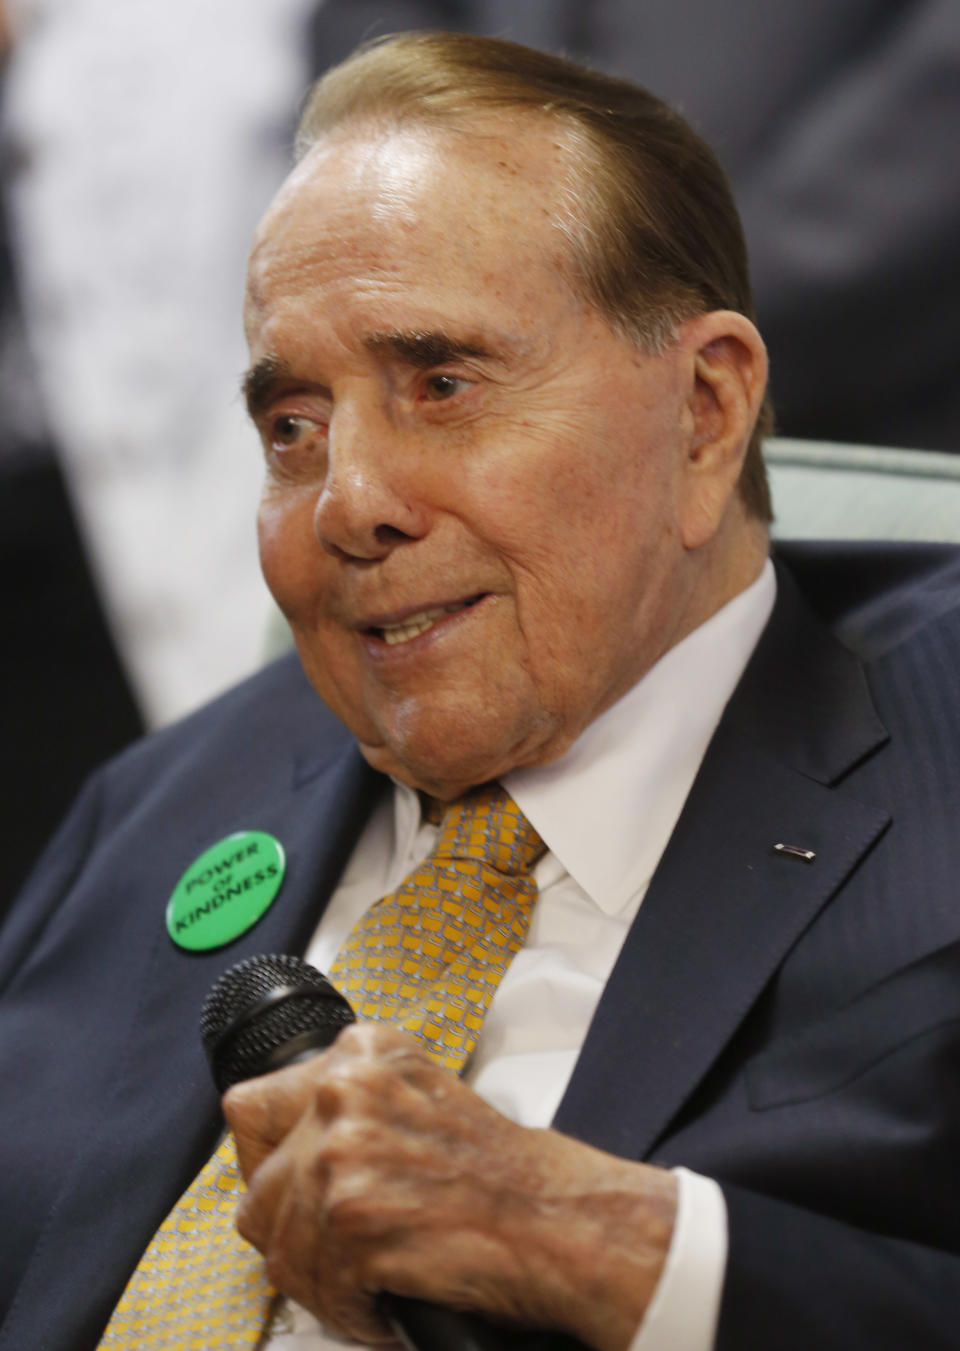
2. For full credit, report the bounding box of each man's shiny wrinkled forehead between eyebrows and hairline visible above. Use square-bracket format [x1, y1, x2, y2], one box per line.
[247, 112, 574, 316]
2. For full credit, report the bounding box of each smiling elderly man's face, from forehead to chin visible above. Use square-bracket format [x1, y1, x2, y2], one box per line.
[247, 116, 734, 796]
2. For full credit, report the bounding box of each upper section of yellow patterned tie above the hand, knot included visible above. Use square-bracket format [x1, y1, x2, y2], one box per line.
[329, 784, 544, 1071]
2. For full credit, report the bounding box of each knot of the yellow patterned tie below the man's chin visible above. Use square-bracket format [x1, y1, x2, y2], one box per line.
[433, 784, 545, 874]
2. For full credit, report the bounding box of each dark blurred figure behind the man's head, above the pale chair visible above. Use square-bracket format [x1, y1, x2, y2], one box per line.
[307, 0, 960, 451]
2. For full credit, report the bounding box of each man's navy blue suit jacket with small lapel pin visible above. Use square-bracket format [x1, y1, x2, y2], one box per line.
[0, 546, 960, 1351]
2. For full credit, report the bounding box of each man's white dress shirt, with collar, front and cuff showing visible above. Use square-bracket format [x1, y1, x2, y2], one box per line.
[266, 562, 775, 1351]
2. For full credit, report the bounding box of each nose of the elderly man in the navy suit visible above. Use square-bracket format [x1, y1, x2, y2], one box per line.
[313, 405, 429, 562]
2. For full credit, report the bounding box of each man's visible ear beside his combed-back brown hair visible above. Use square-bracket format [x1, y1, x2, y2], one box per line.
[678, 309, 767, 549]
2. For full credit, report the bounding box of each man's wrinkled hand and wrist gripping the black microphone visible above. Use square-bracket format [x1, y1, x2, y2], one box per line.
[224, 1023, 675, 1351]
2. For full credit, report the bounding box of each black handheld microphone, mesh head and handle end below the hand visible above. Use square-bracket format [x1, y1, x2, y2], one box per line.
[200, 957, 582, 1351]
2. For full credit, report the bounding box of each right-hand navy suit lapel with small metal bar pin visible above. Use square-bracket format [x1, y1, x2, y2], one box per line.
[554, 564, 888, 1158]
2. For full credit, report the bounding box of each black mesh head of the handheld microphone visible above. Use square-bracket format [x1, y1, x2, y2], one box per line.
[200, 954, 354, 1093]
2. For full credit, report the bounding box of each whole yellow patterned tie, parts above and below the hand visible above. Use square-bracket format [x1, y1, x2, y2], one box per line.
[100, 785, 544, 1351]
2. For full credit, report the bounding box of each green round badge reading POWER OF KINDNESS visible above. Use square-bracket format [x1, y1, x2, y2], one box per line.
[166, 831, 286, 952]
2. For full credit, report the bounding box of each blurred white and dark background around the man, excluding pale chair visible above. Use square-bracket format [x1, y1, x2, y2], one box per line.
[0, 0, 960, 907]
